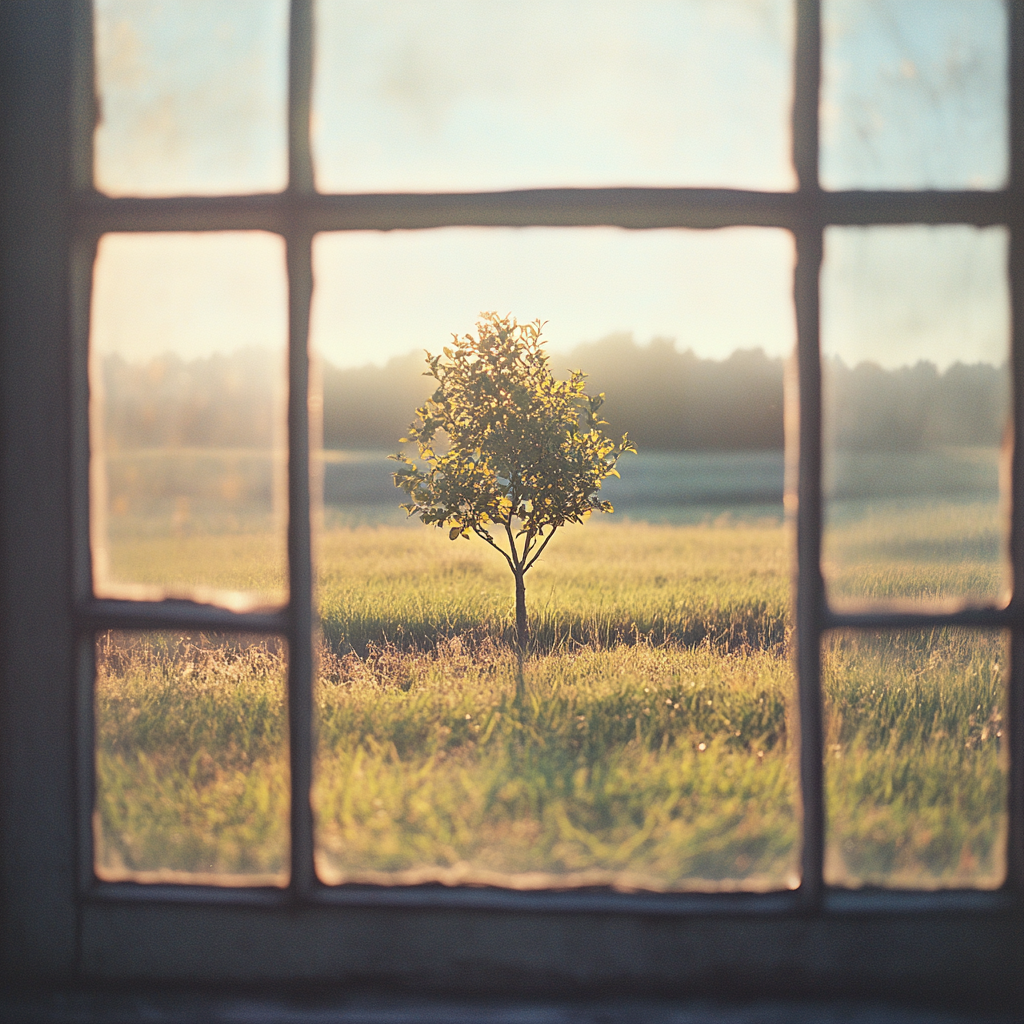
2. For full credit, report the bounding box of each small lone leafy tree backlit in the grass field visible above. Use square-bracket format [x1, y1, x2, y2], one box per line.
[391, 312, 636, 647]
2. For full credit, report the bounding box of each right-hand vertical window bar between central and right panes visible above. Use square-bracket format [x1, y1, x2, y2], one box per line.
[793, 0, 824, 907]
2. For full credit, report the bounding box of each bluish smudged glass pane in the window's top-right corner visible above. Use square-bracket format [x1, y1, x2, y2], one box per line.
[821, 0, 1009, 188]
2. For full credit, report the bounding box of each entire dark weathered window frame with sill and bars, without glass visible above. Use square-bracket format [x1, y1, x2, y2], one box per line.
[0, 0, 1024, 1009]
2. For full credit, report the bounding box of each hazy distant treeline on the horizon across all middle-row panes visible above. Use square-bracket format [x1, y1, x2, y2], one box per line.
[103, 335, 1009, 452]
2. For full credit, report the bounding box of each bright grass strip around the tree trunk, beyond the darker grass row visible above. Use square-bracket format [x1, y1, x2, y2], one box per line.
[321, 521, 790, 654]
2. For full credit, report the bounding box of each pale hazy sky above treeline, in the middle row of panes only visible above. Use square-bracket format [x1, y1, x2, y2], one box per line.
[92, 226, 1010, 370]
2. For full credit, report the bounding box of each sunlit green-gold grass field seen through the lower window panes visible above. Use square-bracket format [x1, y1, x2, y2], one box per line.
[96, 520, 1006, 889]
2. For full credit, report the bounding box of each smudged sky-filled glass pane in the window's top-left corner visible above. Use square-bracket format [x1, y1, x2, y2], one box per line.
[93, 0, 288, 196]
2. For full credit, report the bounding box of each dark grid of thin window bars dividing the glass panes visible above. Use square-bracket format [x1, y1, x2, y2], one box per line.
[76, 0, 1024, 908]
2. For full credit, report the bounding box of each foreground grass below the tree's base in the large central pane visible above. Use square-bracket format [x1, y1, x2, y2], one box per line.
[315, 640, 797, 889]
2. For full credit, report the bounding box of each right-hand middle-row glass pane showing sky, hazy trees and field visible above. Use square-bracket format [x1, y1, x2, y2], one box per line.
[822, 226, 1010, 605]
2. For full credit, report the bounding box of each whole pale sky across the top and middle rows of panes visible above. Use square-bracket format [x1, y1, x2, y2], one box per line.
[93, 0, 1009, 366]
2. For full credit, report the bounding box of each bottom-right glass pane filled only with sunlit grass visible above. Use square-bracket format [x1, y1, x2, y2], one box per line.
[822, 629, 1009, 889]
